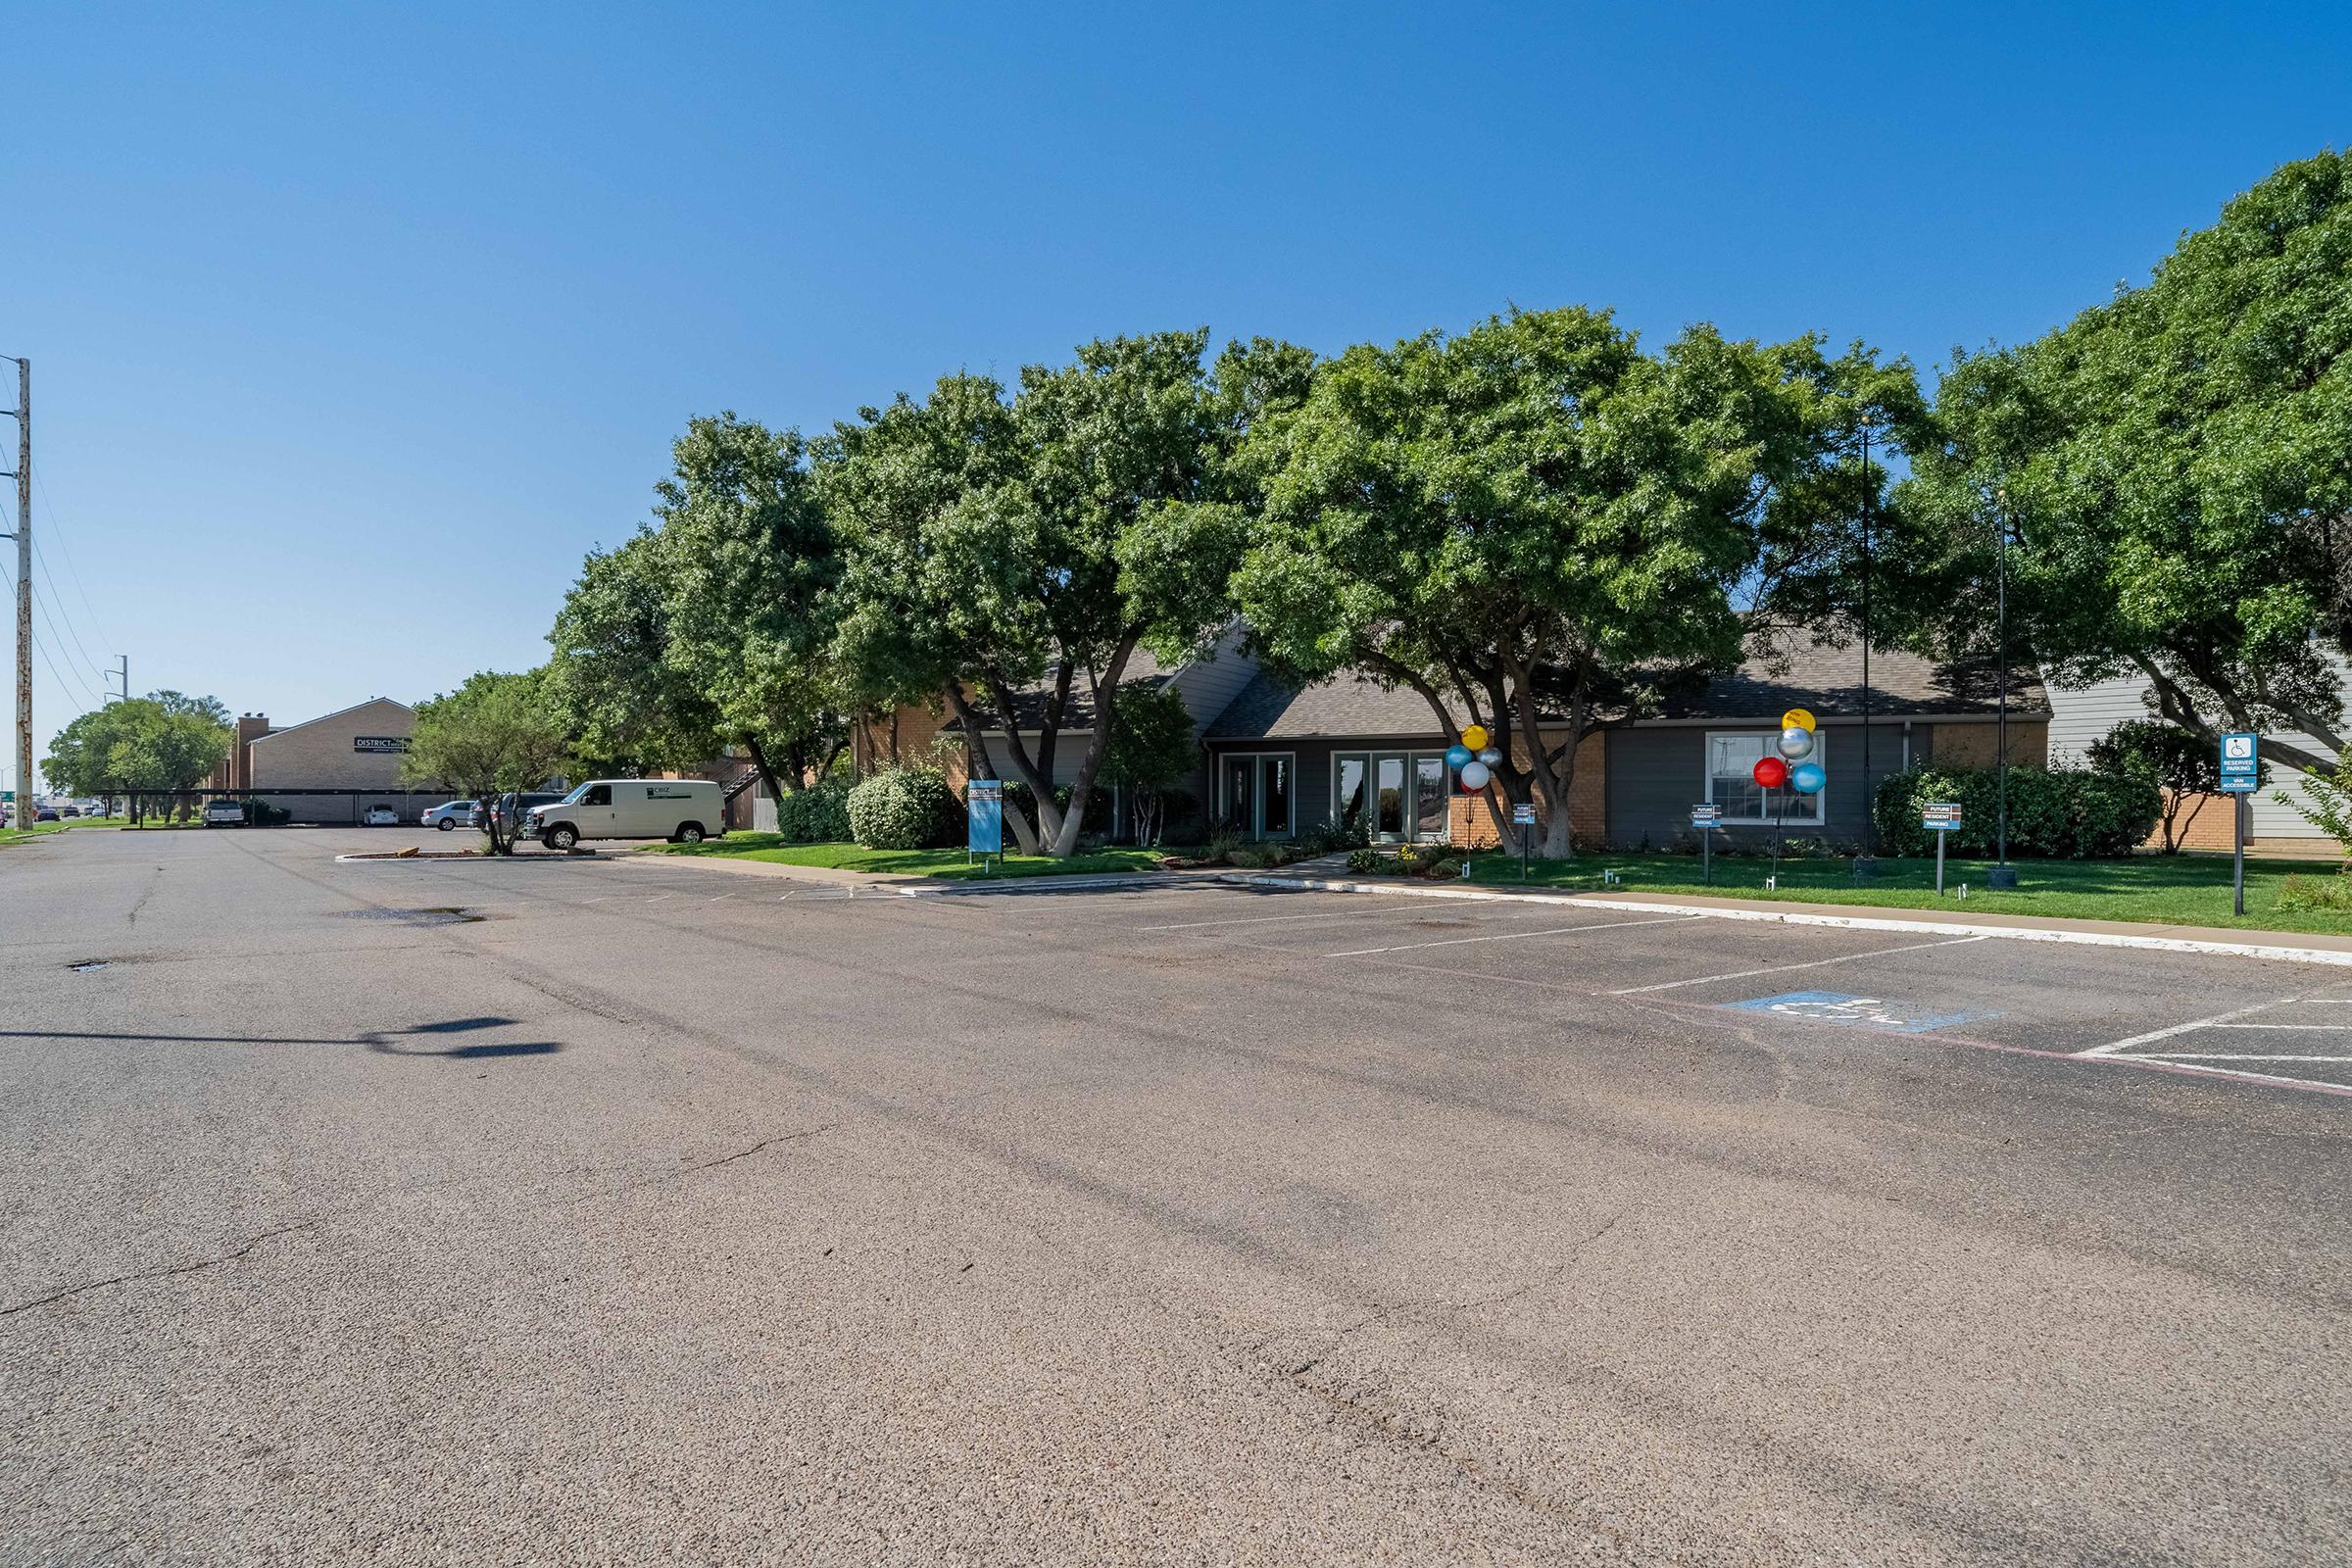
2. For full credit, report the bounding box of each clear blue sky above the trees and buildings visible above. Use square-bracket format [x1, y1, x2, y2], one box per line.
[0, 5, 2352, 785]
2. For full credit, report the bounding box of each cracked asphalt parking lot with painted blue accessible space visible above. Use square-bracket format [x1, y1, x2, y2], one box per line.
[0, 830, 2352, 1563]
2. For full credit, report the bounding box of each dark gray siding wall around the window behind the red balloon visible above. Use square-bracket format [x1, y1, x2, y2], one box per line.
[1609, 719, 1931, 849]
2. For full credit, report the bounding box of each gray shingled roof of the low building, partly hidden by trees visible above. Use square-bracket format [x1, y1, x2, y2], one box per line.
[1209, 647, 2048, 741]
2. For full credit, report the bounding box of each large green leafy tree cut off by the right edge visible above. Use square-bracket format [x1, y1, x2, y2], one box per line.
[1903, 153, 2352, 771]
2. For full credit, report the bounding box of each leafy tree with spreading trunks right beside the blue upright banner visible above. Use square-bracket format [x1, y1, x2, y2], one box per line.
[823, 331, 1312, 856]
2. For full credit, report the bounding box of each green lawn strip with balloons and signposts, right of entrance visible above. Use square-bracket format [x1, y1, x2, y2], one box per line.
[1470, 854, 2352, 936]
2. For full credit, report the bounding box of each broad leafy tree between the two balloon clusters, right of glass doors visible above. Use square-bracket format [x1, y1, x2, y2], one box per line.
[1235, 308, 1917, 856]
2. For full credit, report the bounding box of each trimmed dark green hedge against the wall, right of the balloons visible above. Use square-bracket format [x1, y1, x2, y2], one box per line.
[1872, 764, 2164, 860]
